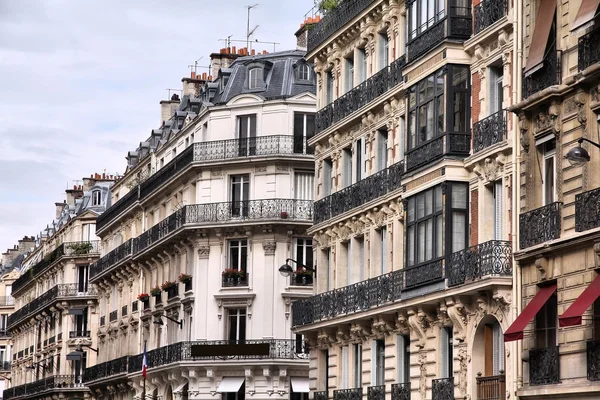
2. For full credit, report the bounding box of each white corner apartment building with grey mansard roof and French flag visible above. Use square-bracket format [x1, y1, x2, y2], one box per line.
[85, 48, 315, 400]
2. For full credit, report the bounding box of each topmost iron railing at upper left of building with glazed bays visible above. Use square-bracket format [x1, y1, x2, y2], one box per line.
[307, 0, 373, 53]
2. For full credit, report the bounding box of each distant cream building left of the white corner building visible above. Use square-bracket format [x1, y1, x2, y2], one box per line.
[0, 174, 115, 399]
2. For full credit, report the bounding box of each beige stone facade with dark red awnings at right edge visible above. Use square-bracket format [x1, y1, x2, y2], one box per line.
[507, 0, 600, 399]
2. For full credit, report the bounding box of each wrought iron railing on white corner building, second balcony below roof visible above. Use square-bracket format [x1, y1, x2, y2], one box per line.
[133, 199, 313, 255]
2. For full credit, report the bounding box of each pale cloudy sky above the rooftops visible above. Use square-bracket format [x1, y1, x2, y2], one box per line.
[0, 0, 314, 252]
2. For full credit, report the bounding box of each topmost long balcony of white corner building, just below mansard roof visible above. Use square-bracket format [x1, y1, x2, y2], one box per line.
[96, 135, 312, 231]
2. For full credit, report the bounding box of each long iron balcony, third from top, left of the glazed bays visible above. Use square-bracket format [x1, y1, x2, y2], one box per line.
[314, 161, 404, 224]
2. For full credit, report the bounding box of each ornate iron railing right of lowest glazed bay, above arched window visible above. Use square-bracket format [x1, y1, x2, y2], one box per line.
[446, 240, 512, 286]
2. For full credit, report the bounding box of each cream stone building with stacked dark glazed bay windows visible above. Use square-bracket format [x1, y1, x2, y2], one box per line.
[292, 0, 516, 400]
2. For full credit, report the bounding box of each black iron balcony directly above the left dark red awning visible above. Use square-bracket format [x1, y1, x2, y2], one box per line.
[519, 202, 562, 250]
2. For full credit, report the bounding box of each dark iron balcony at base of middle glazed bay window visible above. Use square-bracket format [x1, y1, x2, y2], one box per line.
[406, 133, 471, 171]
